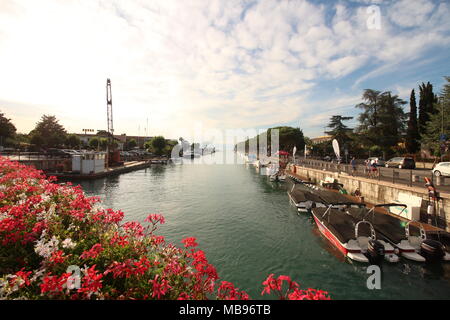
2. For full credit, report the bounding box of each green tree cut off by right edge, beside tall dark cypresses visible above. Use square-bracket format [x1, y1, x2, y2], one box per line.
[422, 77, 450, 156]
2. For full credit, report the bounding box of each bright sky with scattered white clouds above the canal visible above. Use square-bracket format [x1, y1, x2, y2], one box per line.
[0, 0, 450, 138]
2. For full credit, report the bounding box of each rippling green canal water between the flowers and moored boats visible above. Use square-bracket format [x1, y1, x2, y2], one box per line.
[80, 154, 450, 299]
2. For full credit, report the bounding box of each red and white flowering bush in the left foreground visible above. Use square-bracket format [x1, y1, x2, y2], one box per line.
[0, 157, 328, 300]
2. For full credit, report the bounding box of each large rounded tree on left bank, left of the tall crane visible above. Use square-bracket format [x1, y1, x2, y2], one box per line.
[30, 115, 67, 148]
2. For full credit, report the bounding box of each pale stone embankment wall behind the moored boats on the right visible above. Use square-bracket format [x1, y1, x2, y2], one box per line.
[287, 165, 450, 231]
